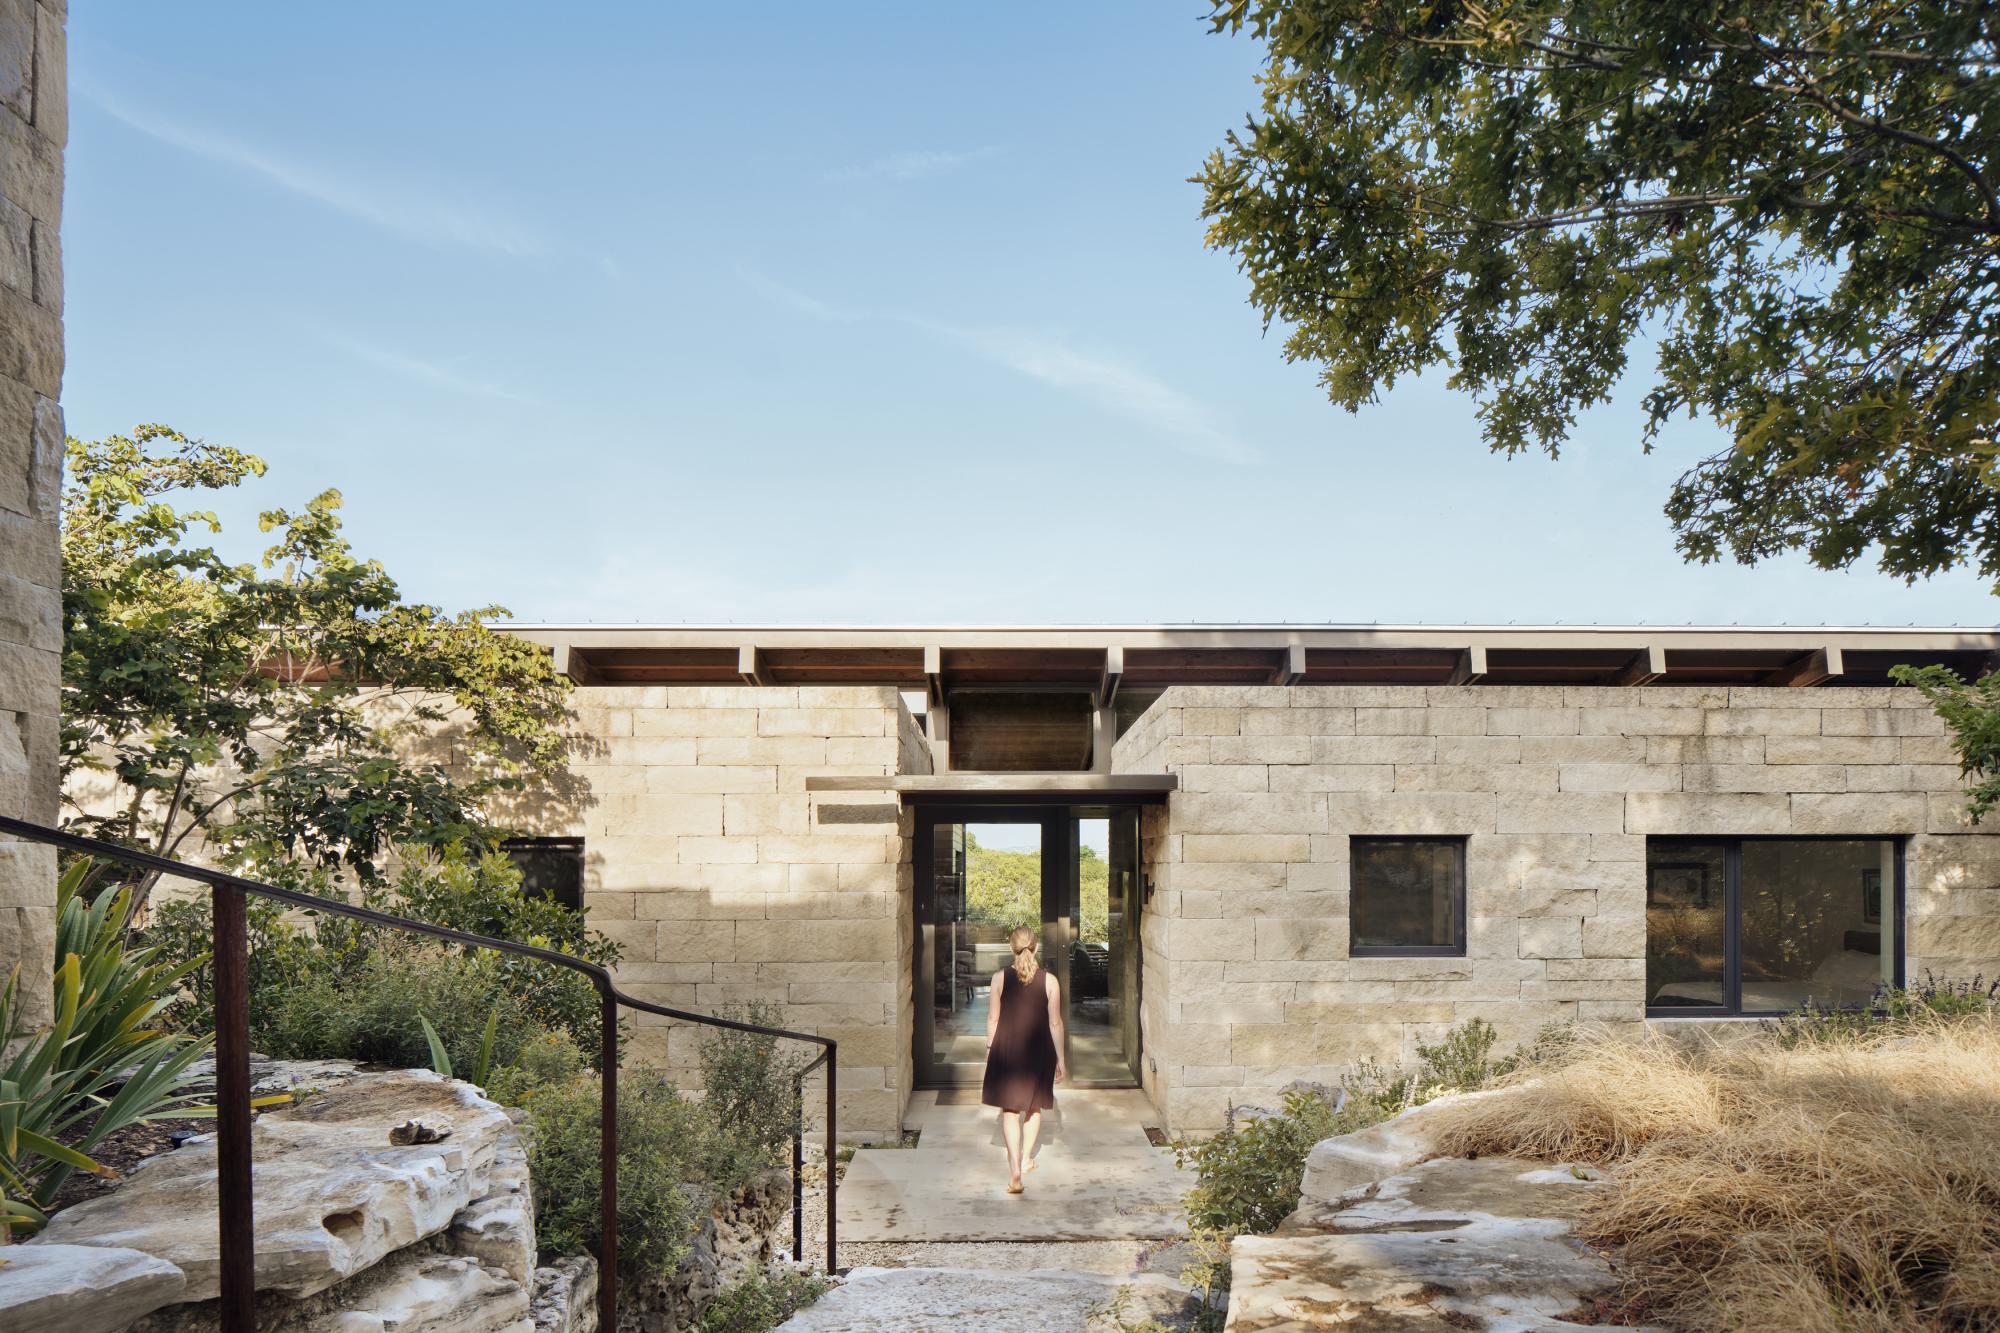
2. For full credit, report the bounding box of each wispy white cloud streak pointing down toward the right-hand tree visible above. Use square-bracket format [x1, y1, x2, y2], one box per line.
[738, 268, 1262, 462]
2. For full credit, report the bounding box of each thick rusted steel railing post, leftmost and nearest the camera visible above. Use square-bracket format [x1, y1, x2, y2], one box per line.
[210, 885, 256, 1333]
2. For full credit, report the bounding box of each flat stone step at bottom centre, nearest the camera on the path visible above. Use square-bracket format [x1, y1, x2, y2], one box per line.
[778, 1269, 1188, 1333]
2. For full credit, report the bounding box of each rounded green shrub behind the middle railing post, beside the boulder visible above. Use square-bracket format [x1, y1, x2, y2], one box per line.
[528, 1069, 714, 1277]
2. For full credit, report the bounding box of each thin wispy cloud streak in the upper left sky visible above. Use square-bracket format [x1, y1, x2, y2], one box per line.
[76, 84, 550, 258]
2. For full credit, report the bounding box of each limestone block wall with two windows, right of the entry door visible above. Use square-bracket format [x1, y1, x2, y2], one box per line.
[1116, 687, 2000, 1131]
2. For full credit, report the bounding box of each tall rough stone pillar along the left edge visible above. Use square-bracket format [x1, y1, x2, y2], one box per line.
[0, 0, 68, 1023]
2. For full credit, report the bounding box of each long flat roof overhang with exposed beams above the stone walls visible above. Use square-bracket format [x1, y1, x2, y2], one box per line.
[502, 624, 2000, 684]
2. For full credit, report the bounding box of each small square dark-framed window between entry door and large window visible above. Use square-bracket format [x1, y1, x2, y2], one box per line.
[1348, 839, 1466, 959]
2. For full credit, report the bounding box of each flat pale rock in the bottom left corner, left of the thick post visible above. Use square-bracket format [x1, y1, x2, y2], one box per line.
[0, 1245, 188, 1333]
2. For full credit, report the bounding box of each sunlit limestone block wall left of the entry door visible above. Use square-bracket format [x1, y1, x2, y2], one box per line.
[534, 685, 928, 1139]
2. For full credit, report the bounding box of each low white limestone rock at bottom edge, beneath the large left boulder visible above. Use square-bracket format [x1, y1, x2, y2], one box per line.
[298, 1255, 534, 1333]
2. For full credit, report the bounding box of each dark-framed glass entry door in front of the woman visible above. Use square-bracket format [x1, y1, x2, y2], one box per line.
[914, 807, 1140, 1087]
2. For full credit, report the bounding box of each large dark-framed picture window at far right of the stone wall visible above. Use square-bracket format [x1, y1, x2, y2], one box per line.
[1646, 839, 1902, 1017]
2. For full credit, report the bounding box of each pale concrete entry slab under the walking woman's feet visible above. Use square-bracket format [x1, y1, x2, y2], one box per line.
[840, 1089, 1194, 1241]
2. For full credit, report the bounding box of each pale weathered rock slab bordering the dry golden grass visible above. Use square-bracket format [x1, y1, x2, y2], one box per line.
[1228, 1157, 1656, 1333]
